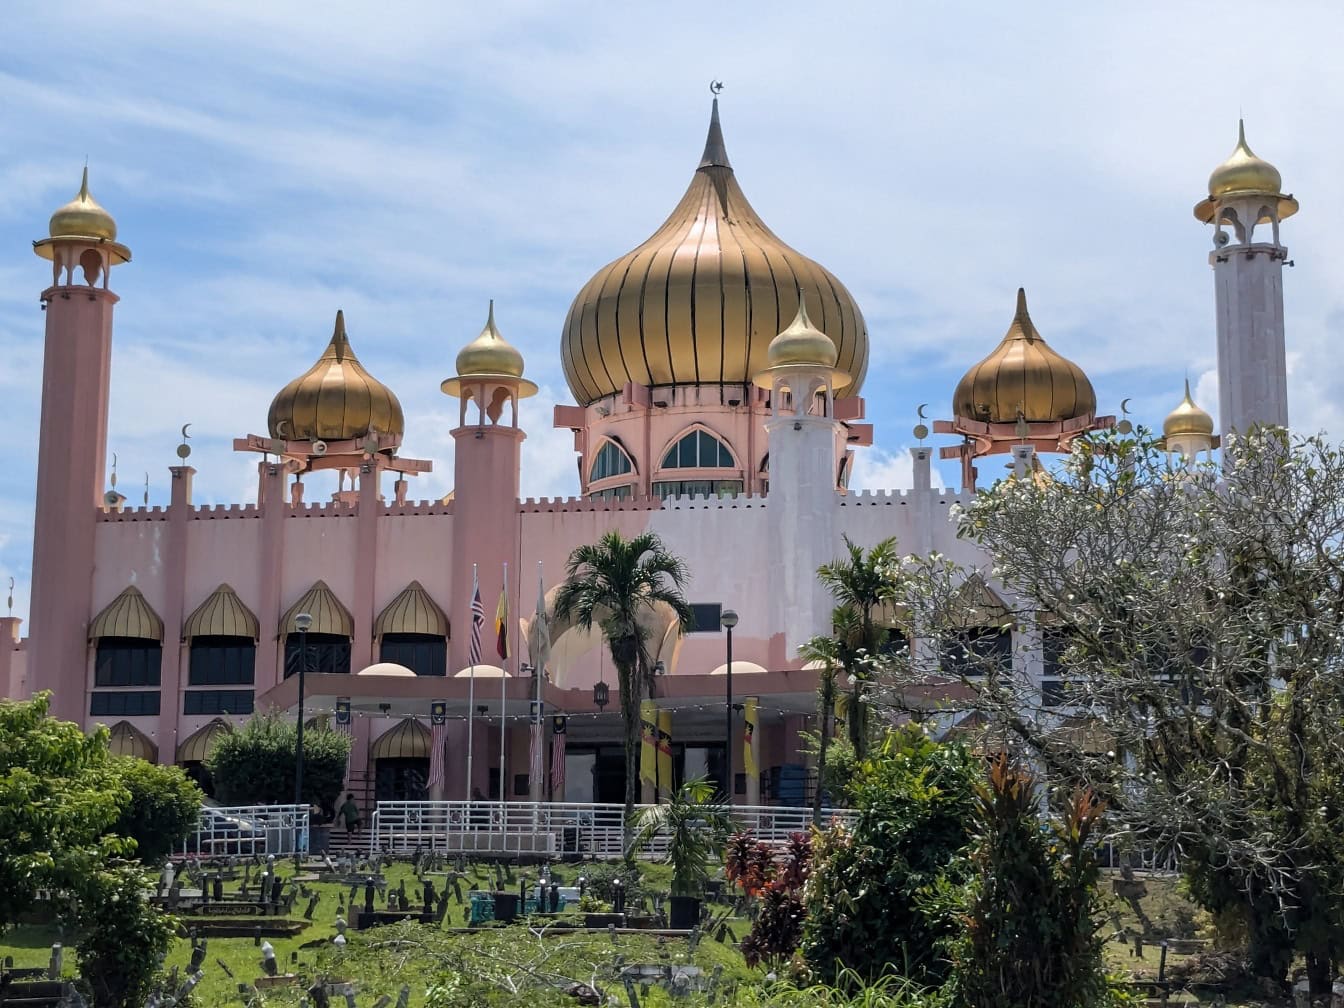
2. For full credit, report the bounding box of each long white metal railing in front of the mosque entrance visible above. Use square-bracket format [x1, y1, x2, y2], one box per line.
[368, 801, 853, 857]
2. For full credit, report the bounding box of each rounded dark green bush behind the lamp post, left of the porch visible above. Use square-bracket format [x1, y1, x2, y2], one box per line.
[206, 711, 349, 808]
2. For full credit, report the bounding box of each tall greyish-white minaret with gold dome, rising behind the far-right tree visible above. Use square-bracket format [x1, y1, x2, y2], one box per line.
[1195, 122, 1297, 433]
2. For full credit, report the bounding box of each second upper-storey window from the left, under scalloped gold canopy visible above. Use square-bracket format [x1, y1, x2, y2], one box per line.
[181, 585, 261, 714]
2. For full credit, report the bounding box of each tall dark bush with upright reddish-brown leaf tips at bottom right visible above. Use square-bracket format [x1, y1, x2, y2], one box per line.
[948, 755, 1111, 1008]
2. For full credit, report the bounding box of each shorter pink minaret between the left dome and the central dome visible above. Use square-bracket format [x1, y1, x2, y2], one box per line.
[441, 301, 536, 675]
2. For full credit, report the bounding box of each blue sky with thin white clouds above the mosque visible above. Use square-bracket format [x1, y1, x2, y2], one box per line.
[0, 1, 1344, 616]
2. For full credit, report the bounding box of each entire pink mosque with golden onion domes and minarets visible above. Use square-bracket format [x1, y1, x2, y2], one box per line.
[0, 102, 1297, 805]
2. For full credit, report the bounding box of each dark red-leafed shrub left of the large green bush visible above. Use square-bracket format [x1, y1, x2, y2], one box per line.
[724, 832, 812, 966]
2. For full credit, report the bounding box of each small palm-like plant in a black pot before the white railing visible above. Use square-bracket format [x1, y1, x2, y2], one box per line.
[629, 777, 732, 930]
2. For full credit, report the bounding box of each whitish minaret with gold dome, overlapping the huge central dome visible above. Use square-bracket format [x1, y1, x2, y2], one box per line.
[755, 293, 851, 660]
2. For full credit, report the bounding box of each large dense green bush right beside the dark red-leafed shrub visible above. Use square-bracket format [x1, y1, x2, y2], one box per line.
[801, 727, 980, 988]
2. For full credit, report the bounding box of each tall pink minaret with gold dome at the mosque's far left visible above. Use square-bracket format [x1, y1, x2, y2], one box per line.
[28, 168, 130, 723]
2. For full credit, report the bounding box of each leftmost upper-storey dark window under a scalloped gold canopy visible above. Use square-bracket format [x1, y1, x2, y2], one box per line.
[89, 585, 164, 718]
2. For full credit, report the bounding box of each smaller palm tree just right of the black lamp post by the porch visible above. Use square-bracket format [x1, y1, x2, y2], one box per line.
[817, 536, 899, 759]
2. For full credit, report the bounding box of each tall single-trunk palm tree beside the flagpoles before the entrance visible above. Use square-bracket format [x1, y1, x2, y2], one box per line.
[555, 531, 694, 823]
